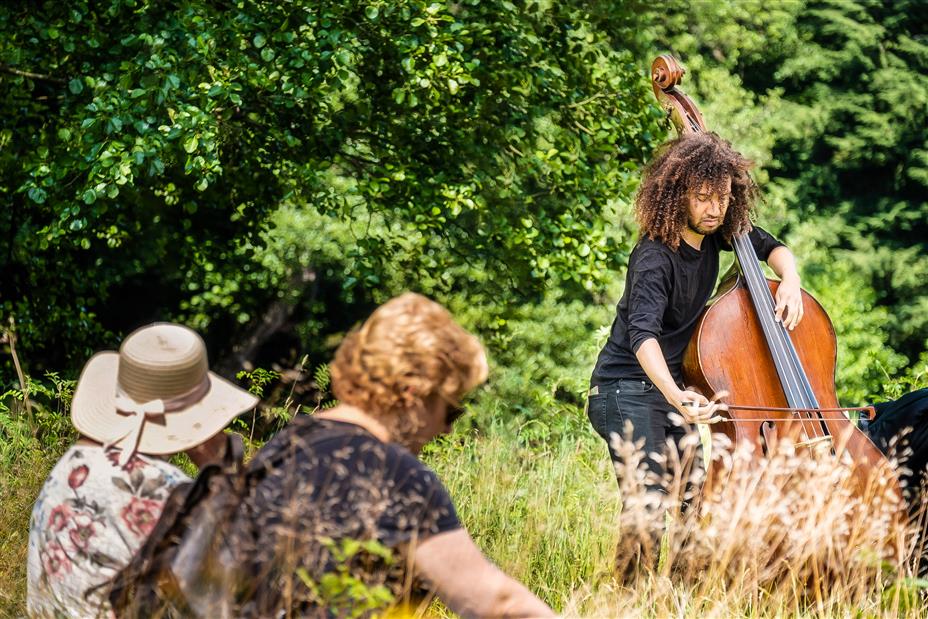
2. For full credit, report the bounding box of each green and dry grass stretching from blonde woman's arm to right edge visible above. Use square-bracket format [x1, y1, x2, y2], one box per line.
[430, 426, 928, 617]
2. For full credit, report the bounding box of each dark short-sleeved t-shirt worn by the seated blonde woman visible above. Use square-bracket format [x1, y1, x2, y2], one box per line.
[225, 415, 461, 617]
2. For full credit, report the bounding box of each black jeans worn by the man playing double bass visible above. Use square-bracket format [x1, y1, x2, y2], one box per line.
[587, 380, 692, 492]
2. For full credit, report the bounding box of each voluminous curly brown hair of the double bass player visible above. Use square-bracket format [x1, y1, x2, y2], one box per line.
[635, 133, 760, 250]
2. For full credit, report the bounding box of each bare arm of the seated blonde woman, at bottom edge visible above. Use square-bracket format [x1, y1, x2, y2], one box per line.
[415, 529, 555, 617]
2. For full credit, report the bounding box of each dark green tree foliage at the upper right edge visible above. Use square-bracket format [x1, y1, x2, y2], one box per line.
[775, 2, 928, 360]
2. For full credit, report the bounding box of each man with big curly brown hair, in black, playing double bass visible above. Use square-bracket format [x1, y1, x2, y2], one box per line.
[588, 133, 802, 491]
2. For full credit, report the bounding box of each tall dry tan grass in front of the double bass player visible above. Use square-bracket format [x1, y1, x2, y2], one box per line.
[588, 437, 928, 617]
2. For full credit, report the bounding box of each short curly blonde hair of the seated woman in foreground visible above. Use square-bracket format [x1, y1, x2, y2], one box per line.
[331, 292, 487, 433]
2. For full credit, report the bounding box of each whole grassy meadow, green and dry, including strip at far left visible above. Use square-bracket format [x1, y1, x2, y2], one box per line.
[7, 400, 928, 617]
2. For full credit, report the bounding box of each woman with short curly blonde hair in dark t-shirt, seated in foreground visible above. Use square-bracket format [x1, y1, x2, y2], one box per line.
[212, 293, 552, 617]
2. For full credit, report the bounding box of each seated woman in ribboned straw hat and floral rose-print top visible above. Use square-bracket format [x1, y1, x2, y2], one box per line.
[27, 323, 257, 617]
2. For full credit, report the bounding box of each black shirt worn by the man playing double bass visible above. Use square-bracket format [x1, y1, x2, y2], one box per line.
[590, 226, 782, 385]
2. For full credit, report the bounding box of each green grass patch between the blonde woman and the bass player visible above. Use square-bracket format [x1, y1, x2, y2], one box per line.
[427, 424, 620, 608]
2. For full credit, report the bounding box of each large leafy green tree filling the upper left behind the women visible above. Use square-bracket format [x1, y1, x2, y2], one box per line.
[0, 0, 662, 372]
